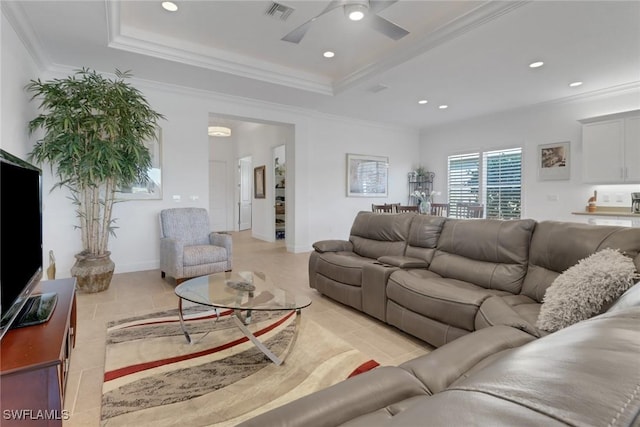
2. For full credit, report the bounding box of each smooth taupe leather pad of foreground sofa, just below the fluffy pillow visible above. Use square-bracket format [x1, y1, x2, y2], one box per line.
[400, 326, 536, 394]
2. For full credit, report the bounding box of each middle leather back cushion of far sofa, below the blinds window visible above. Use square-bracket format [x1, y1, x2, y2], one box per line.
[429, 219, 535, 294]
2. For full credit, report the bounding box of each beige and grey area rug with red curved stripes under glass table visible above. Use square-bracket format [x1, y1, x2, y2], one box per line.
[101, 310, 378, 426]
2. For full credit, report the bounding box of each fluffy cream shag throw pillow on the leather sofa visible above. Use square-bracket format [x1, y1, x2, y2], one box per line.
[536, 249, 636, 332]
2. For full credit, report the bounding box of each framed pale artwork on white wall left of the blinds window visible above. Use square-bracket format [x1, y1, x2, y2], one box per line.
[347, 154, 389, 197]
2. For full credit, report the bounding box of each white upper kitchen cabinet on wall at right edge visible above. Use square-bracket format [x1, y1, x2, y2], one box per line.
[580, 110, 640, 184]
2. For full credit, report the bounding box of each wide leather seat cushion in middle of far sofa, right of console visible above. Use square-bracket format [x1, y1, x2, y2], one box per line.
[387, 270, 506, 331]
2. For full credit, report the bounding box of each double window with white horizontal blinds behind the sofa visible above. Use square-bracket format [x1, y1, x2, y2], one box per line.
[448, 148, 522, 219]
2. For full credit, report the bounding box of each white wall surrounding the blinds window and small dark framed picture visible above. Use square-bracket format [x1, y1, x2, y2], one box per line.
[420, 90, 640, 222]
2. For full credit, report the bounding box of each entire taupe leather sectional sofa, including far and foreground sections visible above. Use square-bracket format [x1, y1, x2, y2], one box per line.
[241, 212, 640, 427]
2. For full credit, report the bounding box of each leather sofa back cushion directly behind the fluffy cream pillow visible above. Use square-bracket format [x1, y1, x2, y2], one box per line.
[521, 221, 640, 302]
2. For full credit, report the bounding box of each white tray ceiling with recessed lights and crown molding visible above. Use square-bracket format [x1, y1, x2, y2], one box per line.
[1, 0, 640, 128]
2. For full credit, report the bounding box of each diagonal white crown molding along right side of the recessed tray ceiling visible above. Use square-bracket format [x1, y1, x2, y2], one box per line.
[333, 0, 531, 94]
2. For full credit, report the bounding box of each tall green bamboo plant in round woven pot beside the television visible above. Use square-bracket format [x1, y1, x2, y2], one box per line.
[26, 68, 163, 292]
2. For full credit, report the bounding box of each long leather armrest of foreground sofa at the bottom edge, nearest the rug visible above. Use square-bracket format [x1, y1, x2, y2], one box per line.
[239, 366, 429, 427]
